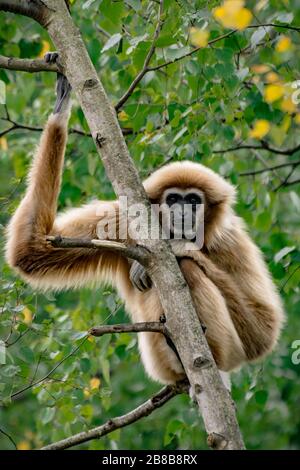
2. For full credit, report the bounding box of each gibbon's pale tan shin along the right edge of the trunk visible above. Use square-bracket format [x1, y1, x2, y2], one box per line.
[179, 258, 246, 371]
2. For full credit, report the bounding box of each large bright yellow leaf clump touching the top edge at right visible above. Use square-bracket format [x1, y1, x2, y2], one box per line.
[213, 0, 253, 30]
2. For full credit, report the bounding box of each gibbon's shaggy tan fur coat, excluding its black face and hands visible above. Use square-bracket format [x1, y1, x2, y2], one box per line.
[6, 112, 284, 383]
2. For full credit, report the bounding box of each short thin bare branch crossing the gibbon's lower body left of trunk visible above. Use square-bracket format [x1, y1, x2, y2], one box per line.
[89, 321, 169, 336]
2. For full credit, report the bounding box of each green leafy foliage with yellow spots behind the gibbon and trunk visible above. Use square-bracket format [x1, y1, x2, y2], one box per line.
[0, 0, 300, 449]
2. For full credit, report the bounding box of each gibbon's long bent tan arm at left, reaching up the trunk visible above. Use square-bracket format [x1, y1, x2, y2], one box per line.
[6, 54, 131, 290]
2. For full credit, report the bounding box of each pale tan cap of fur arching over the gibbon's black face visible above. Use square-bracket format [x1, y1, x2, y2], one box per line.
[143, 161, 236, 206]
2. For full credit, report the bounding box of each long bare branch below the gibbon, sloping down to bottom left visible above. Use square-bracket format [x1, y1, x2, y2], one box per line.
[41, 382, 187, 450]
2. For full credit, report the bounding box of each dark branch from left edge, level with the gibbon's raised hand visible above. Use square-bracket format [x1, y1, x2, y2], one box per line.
[0, 55, 62, 73]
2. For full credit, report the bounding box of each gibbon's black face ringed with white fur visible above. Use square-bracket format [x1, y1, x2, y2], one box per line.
[160, 187, 204, 241]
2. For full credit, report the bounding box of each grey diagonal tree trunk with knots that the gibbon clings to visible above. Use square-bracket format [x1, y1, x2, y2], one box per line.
[0, 0, 244, 449]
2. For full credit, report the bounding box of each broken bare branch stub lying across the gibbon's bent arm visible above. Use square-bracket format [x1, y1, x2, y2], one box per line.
[46, 236, 149, 265]
